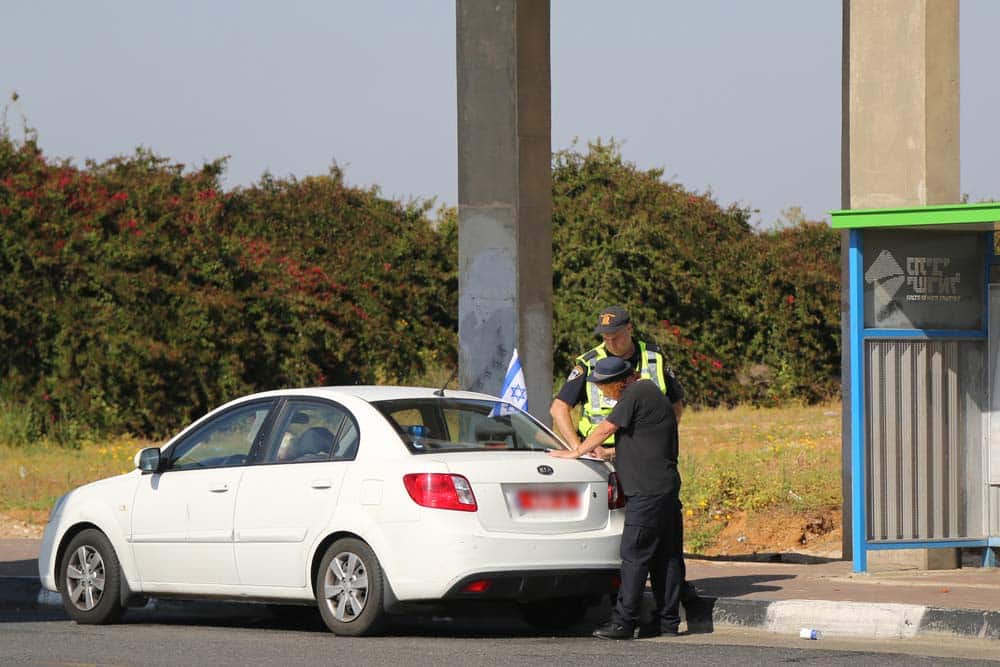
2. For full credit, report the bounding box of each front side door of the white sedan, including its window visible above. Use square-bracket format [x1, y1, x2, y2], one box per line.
[131, 400, 276, 590]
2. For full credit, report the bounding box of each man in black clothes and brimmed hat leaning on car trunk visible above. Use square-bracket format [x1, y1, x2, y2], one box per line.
[550, 357, 684, 639]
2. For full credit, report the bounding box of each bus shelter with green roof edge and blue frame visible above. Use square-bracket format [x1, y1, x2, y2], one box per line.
[831, 203, 1000, 572]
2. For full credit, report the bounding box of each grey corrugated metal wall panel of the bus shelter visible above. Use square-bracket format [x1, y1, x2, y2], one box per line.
[865, 339, 985, 541]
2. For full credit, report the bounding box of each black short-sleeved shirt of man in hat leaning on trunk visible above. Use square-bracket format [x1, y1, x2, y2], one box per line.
[608, 380, 681, 496]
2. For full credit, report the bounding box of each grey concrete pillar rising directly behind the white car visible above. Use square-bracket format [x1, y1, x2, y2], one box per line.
[456, 0, 552, 421]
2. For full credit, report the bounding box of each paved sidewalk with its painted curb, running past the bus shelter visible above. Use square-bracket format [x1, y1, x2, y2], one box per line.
[0, 539, 1000, 640]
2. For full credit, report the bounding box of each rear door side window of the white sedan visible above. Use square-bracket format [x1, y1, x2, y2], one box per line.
[262, 400, 359, 463]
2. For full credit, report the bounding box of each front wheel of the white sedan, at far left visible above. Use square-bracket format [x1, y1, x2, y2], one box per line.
[59, 528, 125, 625]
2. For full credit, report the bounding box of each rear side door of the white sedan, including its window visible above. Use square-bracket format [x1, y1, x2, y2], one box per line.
[235, 398, 359, 588]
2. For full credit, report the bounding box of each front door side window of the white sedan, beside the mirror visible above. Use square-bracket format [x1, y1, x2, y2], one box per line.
[169, 401, 274, 470]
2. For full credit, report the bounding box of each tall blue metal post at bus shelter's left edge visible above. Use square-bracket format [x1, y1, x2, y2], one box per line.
[848, 229, 868, 572]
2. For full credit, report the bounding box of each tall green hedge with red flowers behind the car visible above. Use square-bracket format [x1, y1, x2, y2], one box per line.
[0, 132, 839, 442]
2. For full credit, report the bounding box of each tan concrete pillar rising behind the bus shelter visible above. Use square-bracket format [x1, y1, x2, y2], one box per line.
[841, 0, 961, 569]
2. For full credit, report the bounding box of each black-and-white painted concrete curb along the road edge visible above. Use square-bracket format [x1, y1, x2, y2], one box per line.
[0, 576, 1000, 639]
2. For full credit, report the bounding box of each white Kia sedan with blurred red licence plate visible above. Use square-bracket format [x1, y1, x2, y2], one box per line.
[38, 386, 624, 635]
